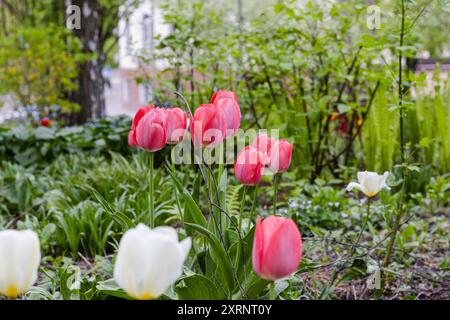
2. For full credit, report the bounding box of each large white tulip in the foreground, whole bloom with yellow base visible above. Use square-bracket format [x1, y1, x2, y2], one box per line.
[114, 224, 191, 300]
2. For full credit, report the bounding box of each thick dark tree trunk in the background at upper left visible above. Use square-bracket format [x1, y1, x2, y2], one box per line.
[66, 0, 105, 124]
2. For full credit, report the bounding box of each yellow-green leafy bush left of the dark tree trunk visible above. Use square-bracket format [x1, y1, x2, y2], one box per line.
[0, 27, 84, 112]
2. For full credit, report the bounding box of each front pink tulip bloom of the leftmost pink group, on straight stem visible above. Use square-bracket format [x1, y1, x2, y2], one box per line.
[135, 108, 167, 152]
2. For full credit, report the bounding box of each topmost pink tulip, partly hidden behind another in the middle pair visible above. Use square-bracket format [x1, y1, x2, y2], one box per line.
[211, 90, 241, 136]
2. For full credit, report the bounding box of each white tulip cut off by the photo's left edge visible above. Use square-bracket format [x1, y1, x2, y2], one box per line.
[0, 230, 41, 298]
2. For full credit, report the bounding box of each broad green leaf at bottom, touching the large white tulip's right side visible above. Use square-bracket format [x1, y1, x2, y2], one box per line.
[175, 274, 226, 300]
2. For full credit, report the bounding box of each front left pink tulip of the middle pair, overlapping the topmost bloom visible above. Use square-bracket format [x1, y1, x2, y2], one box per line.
[190, 104, 227, 147]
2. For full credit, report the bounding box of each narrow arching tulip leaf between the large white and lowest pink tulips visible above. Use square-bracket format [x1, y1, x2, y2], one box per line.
[186, 223, 234, 290]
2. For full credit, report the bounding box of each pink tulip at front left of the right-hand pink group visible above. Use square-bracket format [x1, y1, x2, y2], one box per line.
[234, 146, 264, 185]
